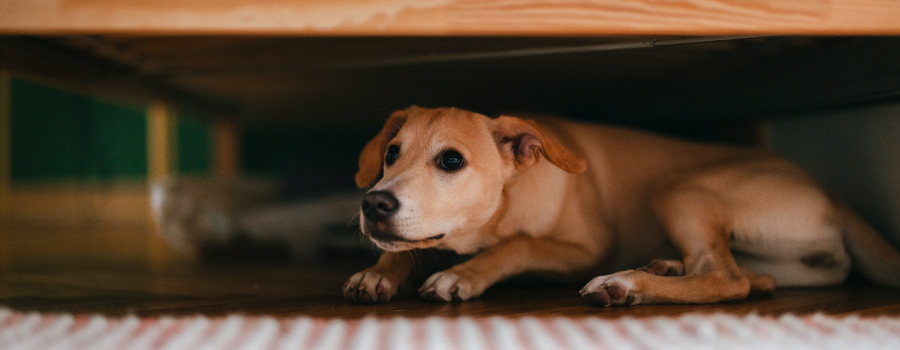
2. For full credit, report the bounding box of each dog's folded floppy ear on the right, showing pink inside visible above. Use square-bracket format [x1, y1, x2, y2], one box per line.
[490, 116, 587, 174]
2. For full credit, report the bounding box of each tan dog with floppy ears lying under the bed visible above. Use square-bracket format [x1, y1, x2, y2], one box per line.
[344, 107, 900, 306]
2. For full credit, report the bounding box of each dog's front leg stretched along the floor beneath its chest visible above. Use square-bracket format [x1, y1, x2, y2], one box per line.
[419, 236, 596, 302]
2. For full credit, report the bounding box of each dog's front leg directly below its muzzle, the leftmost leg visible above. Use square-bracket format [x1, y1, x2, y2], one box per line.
[344, 251, 415, 304]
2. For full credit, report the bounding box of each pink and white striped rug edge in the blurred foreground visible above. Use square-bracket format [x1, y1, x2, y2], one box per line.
[0, 308, 900, 350]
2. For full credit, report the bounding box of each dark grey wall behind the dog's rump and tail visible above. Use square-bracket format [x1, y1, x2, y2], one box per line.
[770, 103, 900, 247]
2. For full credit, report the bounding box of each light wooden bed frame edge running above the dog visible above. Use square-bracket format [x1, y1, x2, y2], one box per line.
[0, 0, 900, 35]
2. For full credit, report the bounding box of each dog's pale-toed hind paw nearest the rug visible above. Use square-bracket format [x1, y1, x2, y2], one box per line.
[579, 270, 645, 307]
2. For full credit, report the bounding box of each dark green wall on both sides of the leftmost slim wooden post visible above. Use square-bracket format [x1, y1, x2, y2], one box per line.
[10, 79, 212, 181]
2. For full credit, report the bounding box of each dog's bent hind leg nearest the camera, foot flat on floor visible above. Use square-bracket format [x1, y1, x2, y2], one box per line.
[581, 186, 774, 306]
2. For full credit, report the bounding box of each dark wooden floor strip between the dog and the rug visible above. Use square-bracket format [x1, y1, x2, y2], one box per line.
[0, 263, 900, 318]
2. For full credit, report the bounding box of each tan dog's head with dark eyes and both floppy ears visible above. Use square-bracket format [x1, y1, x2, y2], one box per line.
[356, 107, 585, 251]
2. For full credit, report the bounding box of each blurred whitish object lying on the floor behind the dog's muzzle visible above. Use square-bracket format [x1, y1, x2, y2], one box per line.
[150, 178, 372, 260]
